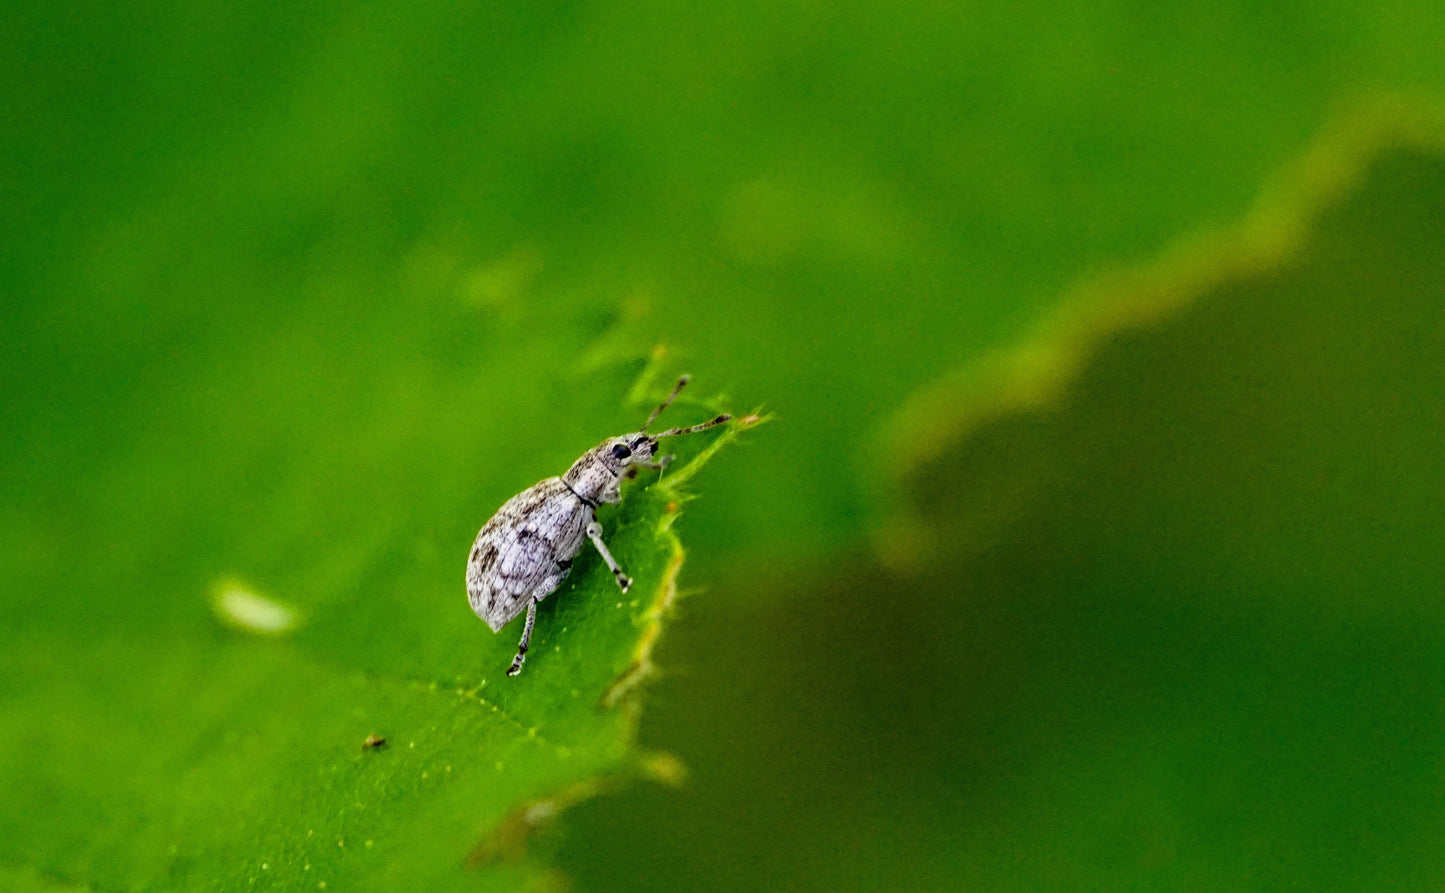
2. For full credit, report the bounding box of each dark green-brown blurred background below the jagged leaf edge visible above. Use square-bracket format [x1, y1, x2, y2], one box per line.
[562, 153, 1445, 890]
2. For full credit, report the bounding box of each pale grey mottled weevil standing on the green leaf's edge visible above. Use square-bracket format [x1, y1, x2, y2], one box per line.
[467, 376, 733, 676]
